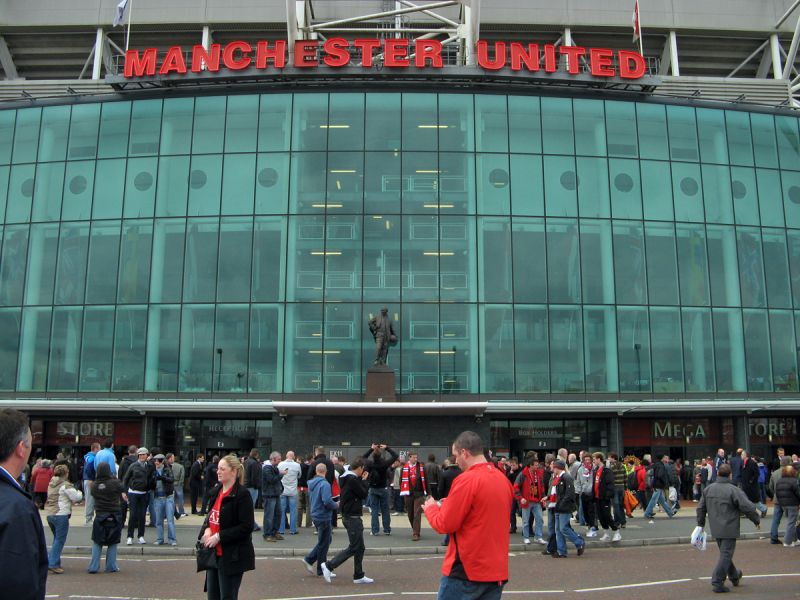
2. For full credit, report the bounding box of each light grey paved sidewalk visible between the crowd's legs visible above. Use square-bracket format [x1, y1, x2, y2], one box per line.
[42, 502, 785, 556]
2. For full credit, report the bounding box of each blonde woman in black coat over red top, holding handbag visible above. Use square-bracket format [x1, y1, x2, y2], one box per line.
[200, 454, 256, 600]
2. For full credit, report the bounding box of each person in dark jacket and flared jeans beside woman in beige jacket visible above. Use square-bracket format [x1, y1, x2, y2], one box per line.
[88, 462, 125, 573]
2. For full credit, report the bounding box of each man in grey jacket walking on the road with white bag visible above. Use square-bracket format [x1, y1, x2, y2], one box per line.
[697, 464, 761, 593]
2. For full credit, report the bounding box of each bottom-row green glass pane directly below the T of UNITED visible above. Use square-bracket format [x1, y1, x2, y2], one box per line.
[548, 305, 585, 392]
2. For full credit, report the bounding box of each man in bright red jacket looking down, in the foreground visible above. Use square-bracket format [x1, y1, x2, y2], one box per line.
[422, 431, 513, 600]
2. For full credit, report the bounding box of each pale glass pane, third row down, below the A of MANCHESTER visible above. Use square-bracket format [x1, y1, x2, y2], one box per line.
[150, 219, 186, 302]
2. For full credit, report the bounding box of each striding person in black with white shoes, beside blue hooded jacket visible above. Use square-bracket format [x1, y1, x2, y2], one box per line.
[320, 458, 374, 584]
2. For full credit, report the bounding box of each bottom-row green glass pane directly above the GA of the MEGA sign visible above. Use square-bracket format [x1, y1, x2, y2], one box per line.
[681, 308, 716, 392]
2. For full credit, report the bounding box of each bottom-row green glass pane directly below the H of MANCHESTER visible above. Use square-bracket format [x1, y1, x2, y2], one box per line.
[248, 304, 284, 392]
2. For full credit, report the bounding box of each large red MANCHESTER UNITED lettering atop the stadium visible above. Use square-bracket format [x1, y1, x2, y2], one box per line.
[124, 37, 647, 80]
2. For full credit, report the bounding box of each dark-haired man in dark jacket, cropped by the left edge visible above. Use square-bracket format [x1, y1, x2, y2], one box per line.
[0, 408, 47, 600]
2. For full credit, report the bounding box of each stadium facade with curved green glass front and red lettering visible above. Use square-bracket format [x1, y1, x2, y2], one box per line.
[0, 0, 800, 458]
